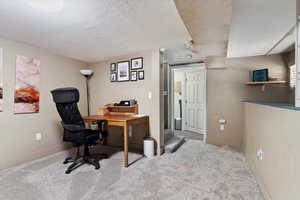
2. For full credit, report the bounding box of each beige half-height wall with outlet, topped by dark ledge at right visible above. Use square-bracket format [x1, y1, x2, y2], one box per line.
[243, 103, 300, 200]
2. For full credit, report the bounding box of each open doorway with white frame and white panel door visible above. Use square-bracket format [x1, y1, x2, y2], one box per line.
[169, 64, 207, 142]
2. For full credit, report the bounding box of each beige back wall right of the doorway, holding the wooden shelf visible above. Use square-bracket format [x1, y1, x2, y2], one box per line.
[206, 55, 291, 148]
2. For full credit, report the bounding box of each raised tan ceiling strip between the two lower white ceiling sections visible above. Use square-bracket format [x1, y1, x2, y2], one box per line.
[169, 0, 232, 63]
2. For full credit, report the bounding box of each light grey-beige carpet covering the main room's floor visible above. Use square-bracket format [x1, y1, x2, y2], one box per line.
[0, 140, 263, 200]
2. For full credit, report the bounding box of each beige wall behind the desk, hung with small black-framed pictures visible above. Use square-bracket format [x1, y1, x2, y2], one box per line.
[90, 50, 161, 154]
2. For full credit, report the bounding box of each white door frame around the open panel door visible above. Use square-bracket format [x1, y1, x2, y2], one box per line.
[169, 63, 207, 143]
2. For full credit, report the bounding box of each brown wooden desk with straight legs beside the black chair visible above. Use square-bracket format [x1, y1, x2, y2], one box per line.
[83, 115, 149, 168]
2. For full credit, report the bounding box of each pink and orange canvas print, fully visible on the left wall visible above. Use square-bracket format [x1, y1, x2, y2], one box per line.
[15, 56, 40, 114]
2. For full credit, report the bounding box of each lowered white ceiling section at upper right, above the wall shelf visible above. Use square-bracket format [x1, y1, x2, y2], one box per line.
[228, 0, 296, 57]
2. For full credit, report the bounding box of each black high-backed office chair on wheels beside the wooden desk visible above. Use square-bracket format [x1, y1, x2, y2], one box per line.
[51, 88, 108, 174]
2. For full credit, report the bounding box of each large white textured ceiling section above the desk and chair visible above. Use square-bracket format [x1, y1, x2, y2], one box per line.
[0, 0, 191, 62]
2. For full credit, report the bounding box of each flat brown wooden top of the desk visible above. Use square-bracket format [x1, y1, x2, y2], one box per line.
[83, 115, 148, 121]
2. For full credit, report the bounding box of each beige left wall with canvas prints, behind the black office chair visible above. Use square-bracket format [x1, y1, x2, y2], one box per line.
[0, 38, 87, 169]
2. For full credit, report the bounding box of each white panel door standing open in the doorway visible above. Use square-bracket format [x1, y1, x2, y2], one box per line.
[185, 70, 206, 134]
